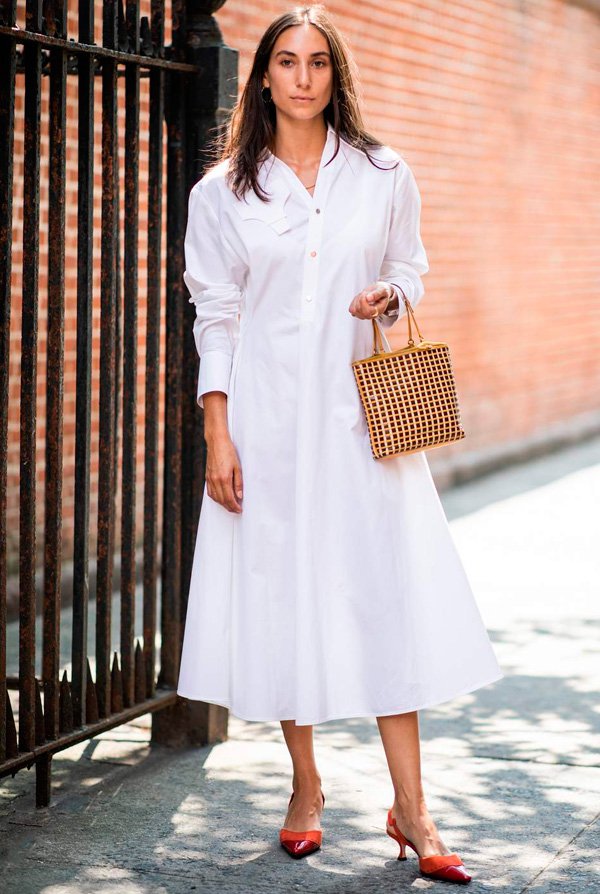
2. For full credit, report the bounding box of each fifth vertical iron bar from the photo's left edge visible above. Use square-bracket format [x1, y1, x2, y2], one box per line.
[96, 0, 119, 717]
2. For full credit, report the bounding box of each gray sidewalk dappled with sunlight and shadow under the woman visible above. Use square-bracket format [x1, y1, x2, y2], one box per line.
[0, 439, 600, 894]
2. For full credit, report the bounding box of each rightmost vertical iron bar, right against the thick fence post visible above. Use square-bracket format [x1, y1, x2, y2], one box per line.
[159, 73, 187, 686]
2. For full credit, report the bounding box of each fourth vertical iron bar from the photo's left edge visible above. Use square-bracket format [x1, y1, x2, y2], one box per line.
[71, 0, 95, 727]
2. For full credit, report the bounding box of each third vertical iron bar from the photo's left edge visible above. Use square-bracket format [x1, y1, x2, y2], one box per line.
[42, 0, 67, 739]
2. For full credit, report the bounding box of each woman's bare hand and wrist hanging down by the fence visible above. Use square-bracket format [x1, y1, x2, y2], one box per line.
[202, 391, 243, 512]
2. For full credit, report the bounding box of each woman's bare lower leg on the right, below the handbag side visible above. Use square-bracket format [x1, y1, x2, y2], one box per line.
[378, 711, 452, 857]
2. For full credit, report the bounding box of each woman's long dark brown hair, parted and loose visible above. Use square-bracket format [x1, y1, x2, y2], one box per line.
[202, 3, 397, 201]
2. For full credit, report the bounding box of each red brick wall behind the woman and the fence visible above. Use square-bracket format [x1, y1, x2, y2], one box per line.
[8, 0, 600, 567]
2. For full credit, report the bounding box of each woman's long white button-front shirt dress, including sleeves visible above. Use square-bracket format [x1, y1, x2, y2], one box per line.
[177, 125, 504, 725]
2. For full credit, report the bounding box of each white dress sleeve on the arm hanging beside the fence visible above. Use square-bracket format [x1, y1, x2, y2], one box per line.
[183, 181, 247, 409]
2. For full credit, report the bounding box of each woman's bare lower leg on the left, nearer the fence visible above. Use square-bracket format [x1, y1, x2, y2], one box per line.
[280, 720, 323, 832]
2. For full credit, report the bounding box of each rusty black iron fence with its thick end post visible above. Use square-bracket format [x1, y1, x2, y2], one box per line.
[0, 0, 237, 806]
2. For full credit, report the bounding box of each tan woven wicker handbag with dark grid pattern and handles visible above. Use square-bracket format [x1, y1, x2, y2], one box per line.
[352, 294, 465, 459]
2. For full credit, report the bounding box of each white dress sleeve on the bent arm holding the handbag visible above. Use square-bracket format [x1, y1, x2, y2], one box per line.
[378, 160, 429, 329]
